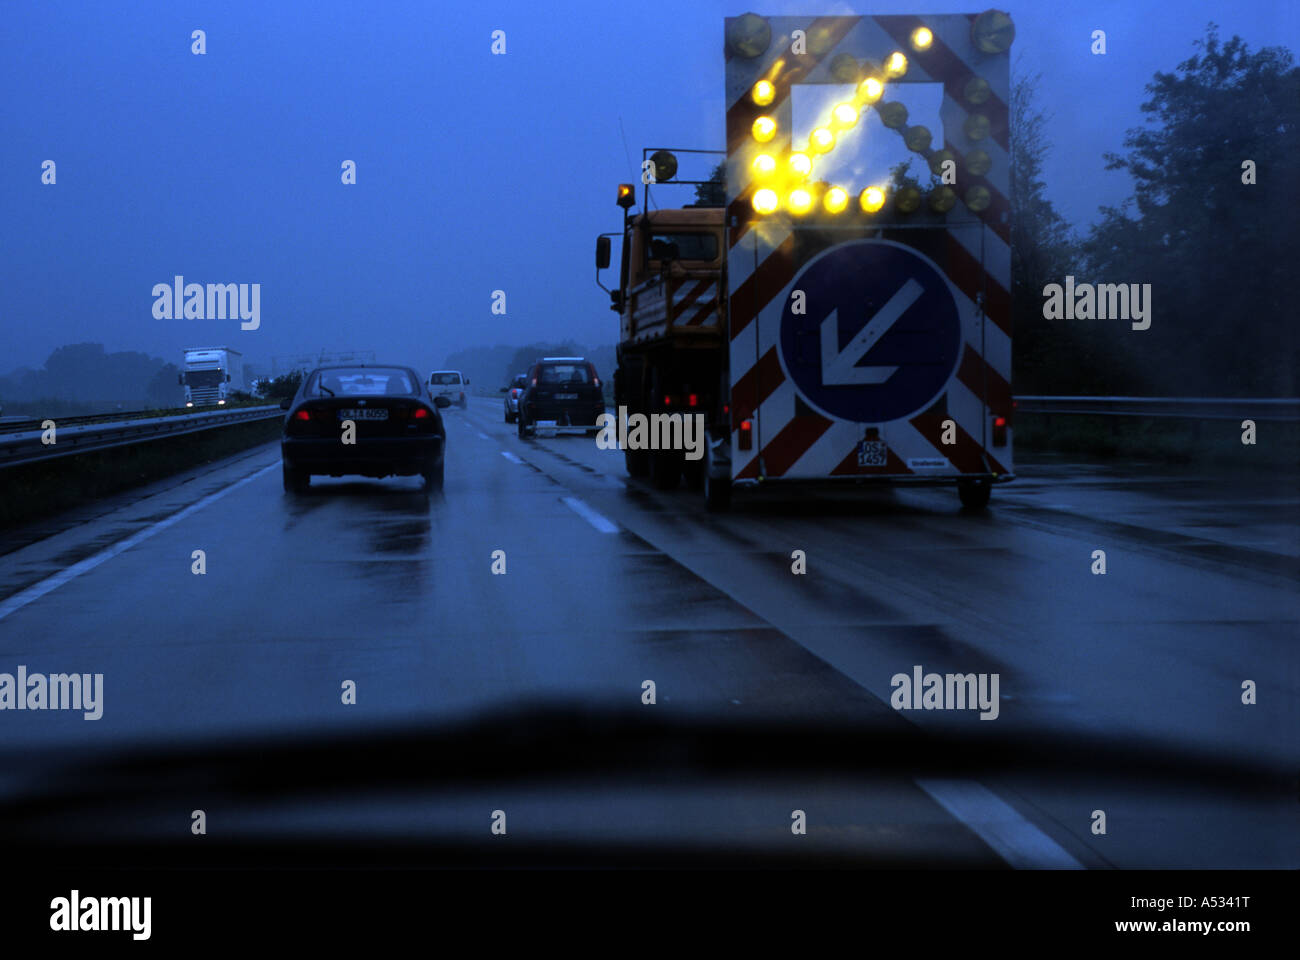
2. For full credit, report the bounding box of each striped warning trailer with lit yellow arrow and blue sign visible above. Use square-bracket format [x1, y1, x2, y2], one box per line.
[728, 10, 1015, 506]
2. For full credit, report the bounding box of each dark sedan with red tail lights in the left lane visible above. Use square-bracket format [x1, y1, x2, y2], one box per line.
[280, 364, 450, 493]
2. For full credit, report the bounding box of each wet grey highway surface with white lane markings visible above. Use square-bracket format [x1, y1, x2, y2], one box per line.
[0, 398, 1300, 868]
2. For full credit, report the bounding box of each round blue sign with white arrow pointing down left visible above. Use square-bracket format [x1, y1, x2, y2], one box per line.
[781, 239, 962, 423]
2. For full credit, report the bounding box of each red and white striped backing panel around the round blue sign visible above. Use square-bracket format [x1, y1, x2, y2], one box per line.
[727, 14, 1013, 480]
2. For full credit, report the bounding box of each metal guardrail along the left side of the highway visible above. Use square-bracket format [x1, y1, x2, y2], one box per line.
[0, 405, 285, 467]
